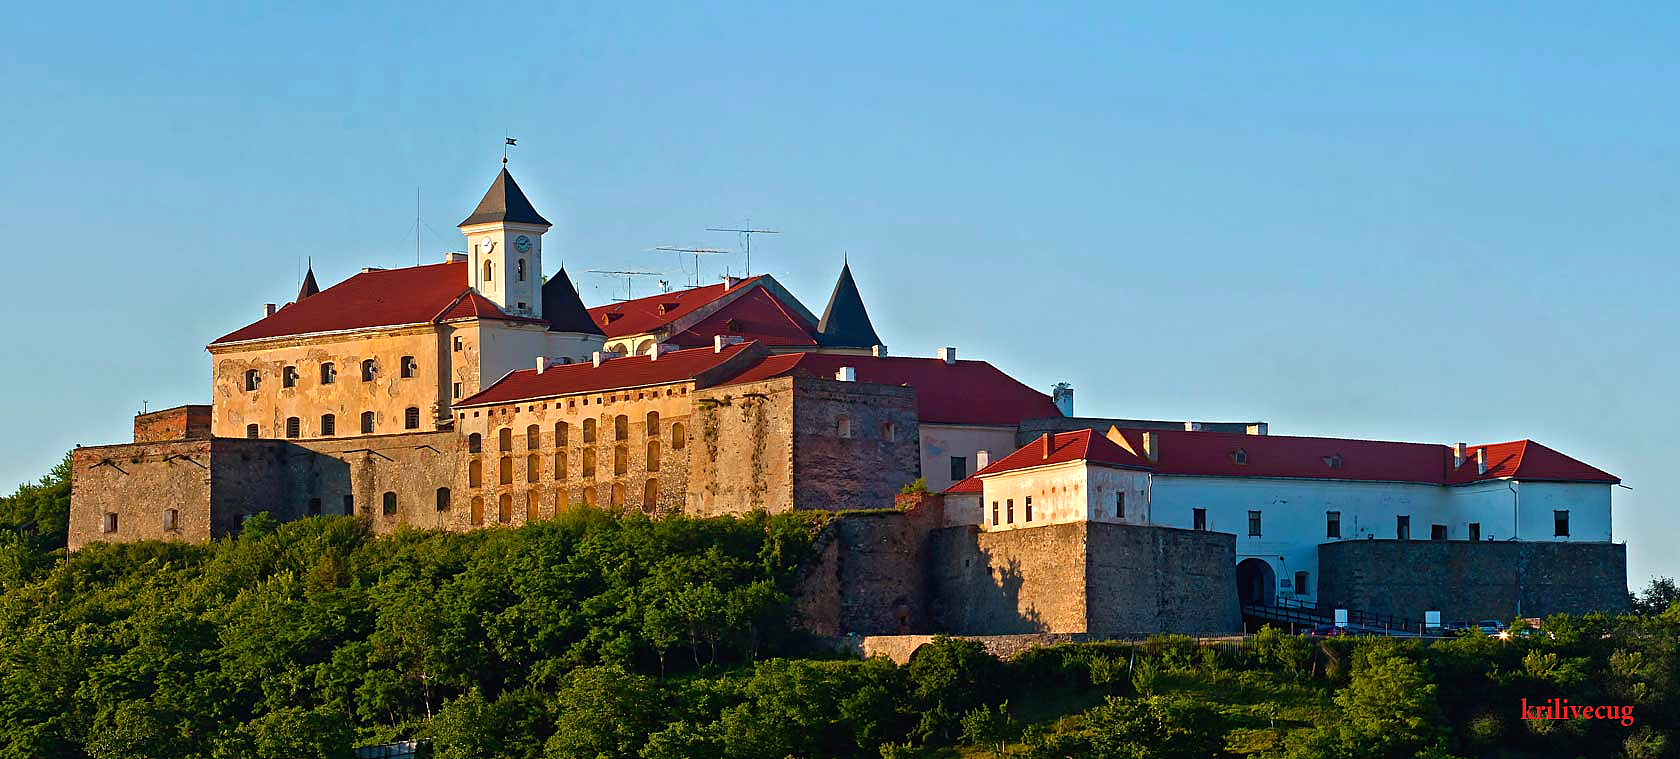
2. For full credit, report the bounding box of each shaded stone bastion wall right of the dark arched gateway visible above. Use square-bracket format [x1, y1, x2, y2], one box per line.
[1319, 541, 1628, 623]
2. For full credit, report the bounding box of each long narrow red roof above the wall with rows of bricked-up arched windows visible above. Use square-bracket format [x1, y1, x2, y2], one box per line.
[455, 343, 763, 408]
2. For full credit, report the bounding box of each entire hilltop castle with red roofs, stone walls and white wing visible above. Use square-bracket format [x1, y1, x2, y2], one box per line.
[69, 168, 1626, 635]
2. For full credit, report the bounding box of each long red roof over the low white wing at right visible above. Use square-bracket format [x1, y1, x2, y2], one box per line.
[946, 430, 1621, 492]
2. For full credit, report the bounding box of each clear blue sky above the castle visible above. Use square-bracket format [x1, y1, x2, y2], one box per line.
[0, 2, 1680, 586]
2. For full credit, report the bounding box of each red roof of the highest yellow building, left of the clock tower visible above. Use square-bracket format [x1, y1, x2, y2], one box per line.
[212, 262, 528, 344]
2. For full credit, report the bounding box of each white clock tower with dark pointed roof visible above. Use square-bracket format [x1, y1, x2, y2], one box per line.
[459, 166, 553, 317]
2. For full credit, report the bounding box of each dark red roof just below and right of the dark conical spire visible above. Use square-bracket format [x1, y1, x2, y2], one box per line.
[729, 353, 1062, 427]
